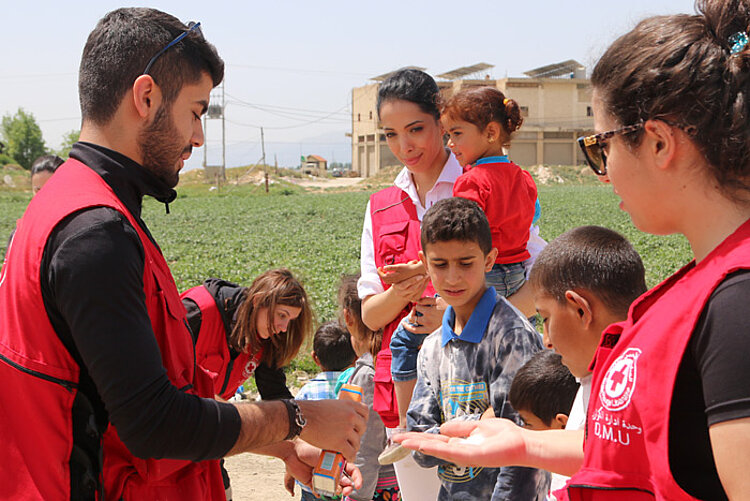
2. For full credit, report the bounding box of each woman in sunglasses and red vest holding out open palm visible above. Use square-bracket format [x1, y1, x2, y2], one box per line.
[405, 0, 750, 500]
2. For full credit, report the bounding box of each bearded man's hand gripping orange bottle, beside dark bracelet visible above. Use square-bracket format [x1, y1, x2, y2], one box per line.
[297, 400, 368, 461]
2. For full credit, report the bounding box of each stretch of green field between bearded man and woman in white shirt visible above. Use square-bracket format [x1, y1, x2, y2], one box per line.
[144, 189, 368, 322]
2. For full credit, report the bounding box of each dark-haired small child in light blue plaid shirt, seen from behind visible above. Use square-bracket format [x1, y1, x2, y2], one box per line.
[292, 322, 356, 501]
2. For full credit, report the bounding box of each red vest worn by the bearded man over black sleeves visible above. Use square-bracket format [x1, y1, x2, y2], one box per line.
[0, 159, 225, 500]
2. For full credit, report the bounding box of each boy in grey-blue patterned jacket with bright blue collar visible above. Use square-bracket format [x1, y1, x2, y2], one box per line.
[407, 198, 546, 501]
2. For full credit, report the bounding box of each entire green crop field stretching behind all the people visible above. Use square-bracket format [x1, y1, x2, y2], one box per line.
[0, 185, 691, 380]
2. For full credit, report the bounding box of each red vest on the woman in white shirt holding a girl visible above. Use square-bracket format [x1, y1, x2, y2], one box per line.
[370, 186, 435, 428]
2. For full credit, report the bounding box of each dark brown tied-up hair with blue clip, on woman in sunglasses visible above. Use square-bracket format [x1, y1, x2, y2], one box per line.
[591, 0, 750, 201]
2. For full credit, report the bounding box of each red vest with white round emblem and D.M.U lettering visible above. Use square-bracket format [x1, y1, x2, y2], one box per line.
[567, 221, 750, 501]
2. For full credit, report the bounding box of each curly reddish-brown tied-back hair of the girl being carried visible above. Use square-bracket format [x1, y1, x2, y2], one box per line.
[442, 86, 523, 144]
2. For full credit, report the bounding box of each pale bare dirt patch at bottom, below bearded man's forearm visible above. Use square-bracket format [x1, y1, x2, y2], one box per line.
[224, 454, 300, 501]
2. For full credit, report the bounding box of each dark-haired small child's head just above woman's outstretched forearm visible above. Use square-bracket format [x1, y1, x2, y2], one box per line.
[509, 350, 578, 430]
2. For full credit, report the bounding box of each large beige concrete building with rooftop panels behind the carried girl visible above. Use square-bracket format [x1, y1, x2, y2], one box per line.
[352, 60, 594, 177]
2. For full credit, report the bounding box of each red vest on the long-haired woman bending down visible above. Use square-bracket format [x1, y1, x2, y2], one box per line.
[180, 285, 263, 400]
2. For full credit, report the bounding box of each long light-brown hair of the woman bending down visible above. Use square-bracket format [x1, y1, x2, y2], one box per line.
[230, 268, 313, 368]
